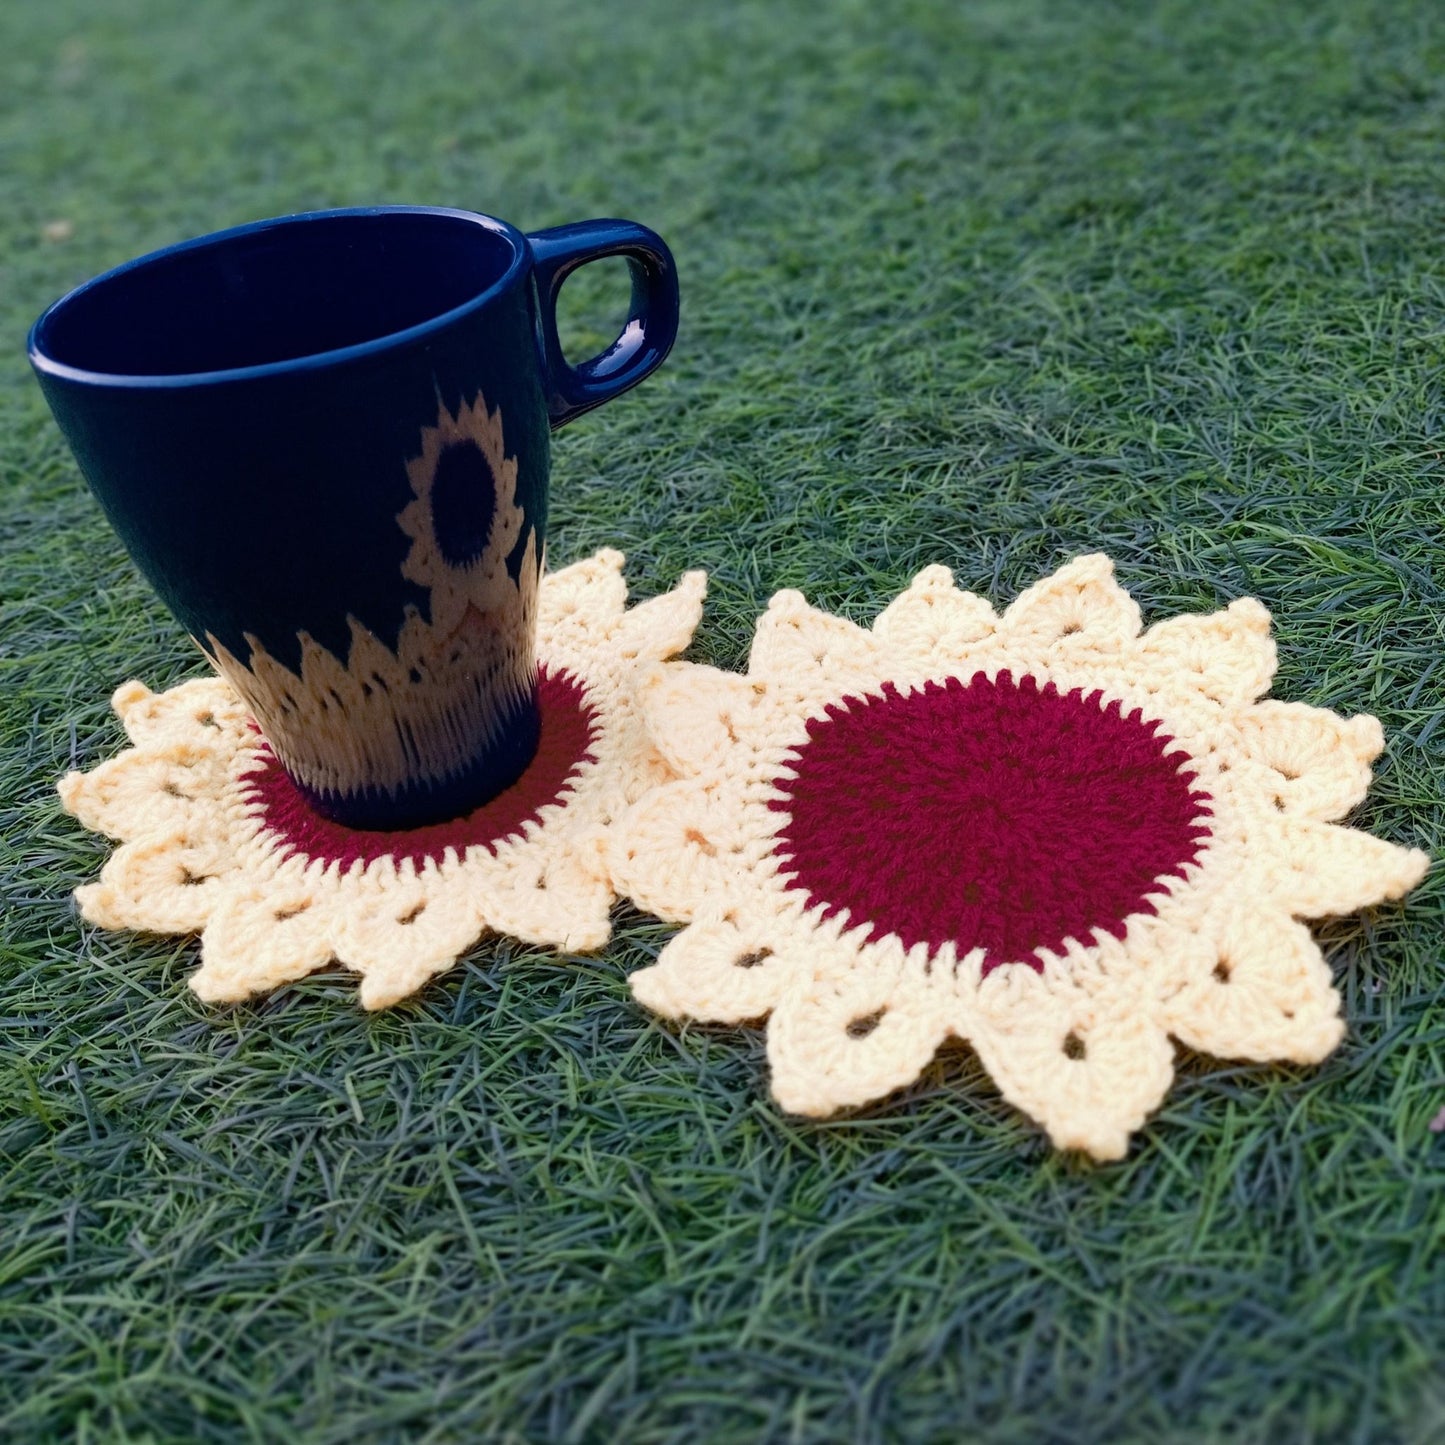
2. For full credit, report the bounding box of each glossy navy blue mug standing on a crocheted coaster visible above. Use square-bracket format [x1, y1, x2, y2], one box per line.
[30, 207, 678, 828]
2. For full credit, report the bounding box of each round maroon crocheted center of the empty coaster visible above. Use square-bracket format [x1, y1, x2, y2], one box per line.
[770, 672, 1211, 972]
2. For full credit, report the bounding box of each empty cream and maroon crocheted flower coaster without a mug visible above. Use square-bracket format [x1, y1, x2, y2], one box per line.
[613, 556, 1428, 1159]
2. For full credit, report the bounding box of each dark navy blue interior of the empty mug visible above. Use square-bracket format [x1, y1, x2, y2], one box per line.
[35, 210, 520, 376]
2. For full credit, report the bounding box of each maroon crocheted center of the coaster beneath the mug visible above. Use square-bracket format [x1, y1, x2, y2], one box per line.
[241, 668, 594, 868]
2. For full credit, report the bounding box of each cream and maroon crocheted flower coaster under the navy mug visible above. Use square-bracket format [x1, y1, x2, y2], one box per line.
[59, 551, 705, 1009]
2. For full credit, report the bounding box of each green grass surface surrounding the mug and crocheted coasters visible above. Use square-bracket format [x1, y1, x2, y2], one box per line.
[0, 0, 1445, 1442]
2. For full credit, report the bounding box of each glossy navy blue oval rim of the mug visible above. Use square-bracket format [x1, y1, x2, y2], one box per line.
[26, 205, 527, 389]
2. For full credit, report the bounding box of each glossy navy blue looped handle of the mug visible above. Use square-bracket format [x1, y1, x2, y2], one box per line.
[527, 221, 678, 431]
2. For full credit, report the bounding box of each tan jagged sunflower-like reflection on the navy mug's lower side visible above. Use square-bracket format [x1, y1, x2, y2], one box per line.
[207, 396, 540, 796]
